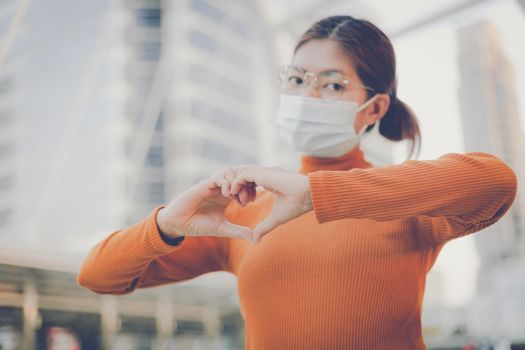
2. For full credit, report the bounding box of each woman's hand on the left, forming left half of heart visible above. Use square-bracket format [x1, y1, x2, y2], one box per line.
[157, 168, 256, 241]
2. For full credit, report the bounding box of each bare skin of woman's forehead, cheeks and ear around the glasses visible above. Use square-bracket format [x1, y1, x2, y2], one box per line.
[292, 39, 389, 133]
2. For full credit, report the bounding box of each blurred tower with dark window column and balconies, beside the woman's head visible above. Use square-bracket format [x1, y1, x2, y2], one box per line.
[124, 0, 276, 223]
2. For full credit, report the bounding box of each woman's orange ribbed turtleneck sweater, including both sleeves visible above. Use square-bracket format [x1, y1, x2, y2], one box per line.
[78, 149, 516, 350]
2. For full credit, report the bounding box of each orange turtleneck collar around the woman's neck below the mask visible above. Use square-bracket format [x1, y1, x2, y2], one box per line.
[299, 147, 372, 175]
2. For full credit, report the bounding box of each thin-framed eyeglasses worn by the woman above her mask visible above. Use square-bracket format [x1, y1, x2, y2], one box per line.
[279, 65, 375, 101]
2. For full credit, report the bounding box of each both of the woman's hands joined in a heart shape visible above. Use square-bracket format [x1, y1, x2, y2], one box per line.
[157, 165, 312, 242]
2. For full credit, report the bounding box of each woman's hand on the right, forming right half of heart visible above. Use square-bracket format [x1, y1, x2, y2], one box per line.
[230, 166, 312, 242]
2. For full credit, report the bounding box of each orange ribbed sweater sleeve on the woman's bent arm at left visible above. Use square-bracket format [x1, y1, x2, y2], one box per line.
[77, 206, 228, 294]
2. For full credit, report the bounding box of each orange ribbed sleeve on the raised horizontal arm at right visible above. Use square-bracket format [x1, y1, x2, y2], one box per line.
[308, 153, 517, 244]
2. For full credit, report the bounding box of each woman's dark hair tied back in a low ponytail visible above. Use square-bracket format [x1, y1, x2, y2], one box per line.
[294, 16, 421, 158]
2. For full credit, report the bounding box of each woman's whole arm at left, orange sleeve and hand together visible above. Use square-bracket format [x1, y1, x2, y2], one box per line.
[77, 169, 255, 294]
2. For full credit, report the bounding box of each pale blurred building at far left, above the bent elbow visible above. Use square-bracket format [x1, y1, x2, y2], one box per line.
[0, 1, 124, 254]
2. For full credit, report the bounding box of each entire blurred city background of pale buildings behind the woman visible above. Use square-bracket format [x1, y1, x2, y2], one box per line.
[0, 0, 525, 350]
